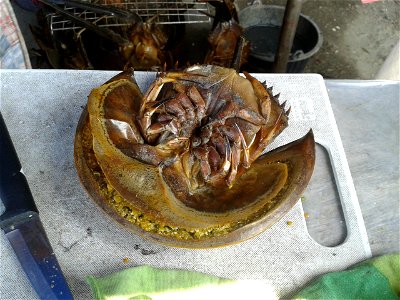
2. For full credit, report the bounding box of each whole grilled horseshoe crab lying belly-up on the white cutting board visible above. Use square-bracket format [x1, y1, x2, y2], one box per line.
[75, 65, 315, 248]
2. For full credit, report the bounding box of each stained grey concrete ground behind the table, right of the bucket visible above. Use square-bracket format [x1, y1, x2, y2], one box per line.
[12, 0, 400, 79]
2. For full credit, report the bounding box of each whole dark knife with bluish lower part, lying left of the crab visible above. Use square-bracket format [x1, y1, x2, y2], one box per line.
[0, 113, 73, 299]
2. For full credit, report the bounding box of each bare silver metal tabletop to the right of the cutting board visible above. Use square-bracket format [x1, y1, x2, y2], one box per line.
[321, 80, 400, 256]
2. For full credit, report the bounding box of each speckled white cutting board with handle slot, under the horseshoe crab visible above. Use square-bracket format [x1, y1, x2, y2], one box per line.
[0, 70, 388, 299]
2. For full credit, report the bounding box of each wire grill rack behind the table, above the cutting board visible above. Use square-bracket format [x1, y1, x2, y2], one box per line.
[47, 0, 211, 32]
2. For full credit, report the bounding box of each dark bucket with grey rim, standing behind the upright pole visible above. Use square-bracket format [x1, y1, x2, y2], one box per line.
[239, 4, 322, 73]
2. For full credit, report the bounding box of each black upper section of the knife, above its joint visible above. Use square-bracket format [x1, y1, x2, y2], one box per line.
[0, 112, 38, 221]
